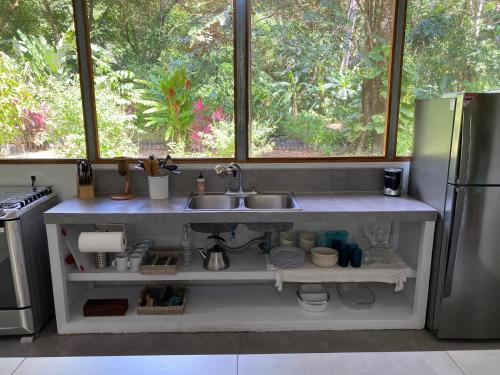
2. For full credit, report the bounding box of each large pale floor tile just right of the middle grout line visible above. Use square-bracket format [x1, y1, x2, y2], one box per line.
[238, 352, 463, 375]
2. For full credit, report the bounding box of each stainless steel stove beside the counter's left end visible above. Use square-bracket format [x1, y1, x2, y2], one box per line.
[0, 186, 58, 335]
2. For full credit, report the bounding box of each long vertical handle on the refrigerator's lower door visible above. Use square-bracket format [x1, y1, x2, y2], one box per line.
[443, 187, 467, 297]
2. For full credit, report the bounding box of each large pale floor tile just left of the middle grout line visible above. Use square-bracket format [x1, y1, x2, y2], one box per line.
[15, 355, 237, 375]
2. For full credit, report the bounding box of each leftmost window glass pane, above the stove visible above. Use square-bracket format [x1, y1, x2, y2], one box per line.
[0, 0, 85, 159]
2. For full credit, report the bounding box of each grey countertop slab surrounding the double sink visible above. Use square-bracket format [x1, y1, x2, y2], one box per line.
[45, 192, 437, 224]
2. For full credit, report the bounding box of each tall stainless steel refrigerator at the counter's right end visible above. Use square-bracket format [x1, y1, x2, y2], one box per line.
[409, 93, 500, 339]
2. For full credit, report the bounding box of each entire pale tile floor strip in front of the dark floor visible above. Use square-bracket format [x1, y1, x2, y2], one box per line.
[0, 350, 500, 375]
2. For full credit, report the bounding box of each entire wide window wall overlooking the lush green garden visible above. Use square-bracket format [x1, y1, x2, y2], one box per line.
[0, 0, 492, 162]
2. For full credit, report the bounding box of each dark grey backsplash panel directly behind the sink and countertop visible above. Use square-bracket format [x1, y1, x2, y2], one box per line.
[95, 167, 384, 195]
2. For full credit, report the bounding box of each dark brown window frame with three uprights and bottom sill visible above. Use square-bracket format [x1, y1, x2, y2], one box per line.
[0, 0, 410, 164]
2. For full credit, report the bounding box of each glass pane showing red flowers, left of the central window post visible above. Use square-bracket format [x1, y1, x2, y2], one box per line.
[87, 0, 235, 158]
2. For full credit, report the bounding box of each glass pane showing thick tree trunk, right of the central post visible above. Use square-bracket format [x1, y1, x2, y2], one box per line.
[250, 0, 394, 158]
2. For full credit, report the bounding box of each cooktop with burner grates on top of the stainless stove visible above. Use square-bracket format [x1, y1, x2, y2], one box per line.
[0, 186, 55, 220]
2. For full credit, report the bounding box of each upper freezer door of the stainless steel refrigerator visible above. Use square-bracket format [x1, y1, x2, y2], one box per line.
[448, 93, 500, 185]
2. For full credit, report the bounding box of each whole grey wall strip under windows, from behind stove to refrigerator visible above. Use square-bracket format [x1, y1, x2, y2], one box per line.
[0, 162, 410, 199]
